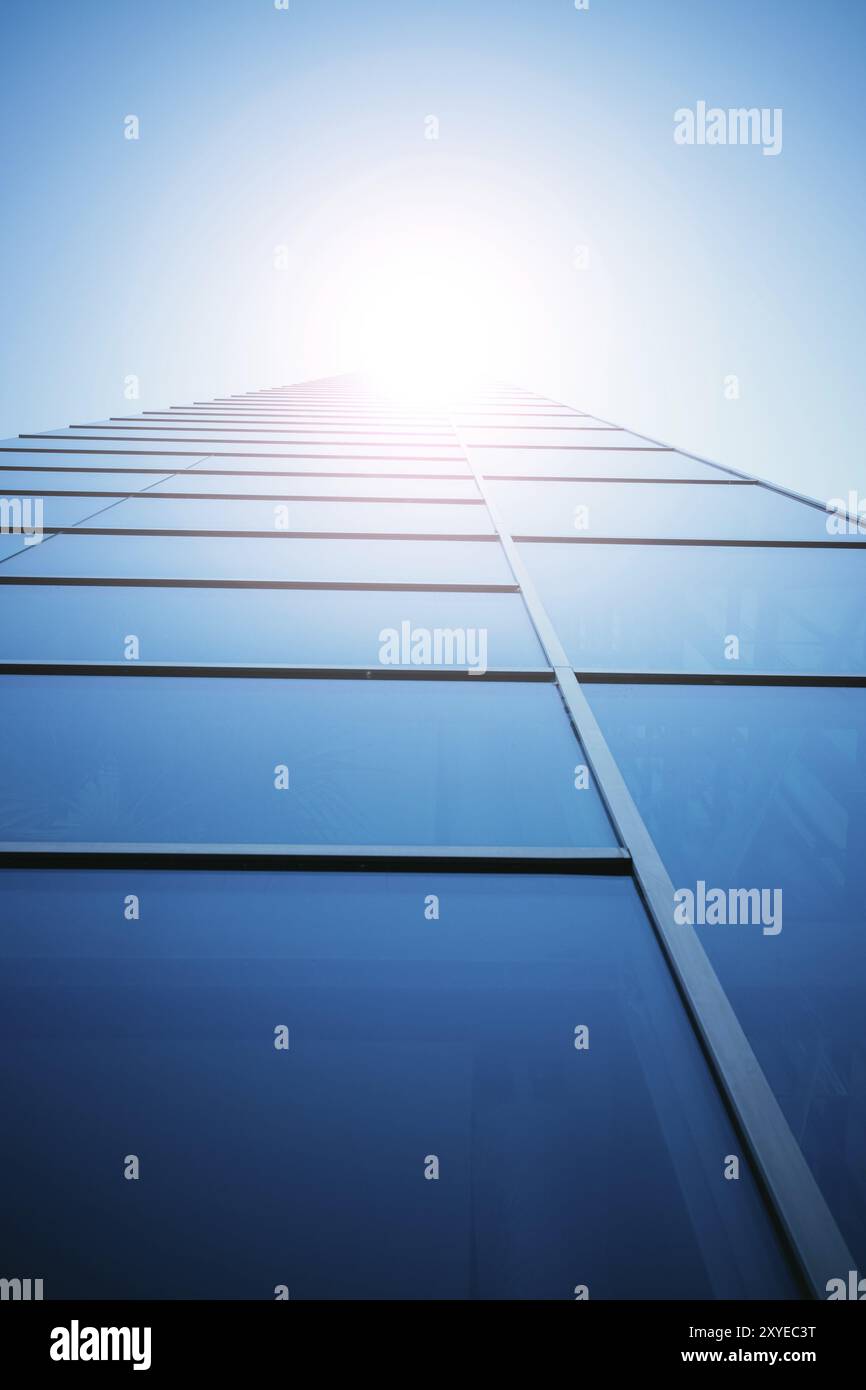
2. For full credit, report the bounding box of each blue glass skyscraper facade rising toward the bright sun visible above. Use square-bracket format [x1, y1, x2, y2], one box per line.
[0, 377, 866, 1300]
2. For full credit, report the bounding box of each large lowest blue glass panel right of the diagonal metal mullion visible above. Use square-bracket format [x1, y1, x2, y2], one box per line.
[587, 685, 866, 1276]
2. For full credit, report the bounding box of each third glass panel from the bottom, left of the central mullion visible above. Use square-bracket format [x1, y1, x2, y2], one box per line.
[0, 584, 545, 670]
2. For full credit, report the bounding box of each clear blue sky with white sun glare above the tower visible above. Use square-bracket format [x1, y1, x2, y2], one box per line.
[0, 0, 866, 498]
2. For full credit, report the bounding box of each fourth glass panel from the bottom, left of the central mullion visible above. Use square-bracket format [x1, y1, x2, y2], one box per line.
[3, 532, 514, 584]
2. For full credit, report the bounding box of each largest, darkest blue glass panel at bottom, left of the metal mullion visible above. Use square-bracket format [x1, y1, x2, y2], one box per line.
[0, 870, 795, 1300]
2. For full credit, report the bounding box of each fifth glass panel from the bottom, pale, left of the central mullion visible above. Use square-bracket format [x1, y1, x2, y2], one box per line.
[84, 493, 495, 535]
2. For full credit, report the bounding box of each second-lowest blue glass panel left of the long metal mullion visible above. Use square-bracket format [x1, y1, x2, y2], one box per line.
[0, 675, 614, 845]
